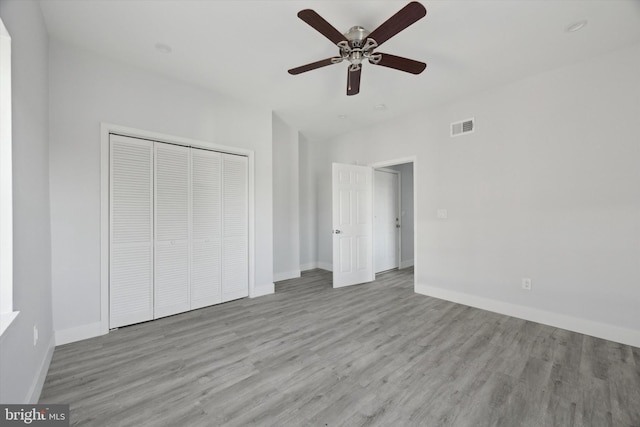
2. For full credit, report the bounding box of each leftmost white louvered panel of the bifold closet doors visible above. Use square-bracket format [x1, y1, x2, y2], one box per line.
[109, 135, 153, 328]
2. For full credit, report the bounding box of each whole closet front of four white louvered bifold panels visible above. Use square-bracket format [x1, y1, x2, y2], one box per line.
[109, 134, 249, 328]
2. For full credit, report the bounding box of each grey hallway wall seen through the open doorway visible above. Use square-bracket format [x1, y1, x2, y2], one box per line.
[389, 163, 414, 268]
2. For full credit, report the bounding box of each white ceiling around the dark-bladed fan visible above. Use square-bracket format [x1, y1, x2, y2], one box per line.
[41, 0, 640, 140]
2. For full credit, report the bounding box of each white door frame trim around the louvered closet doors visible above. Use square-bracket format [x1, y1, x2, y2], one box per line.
[100, 122, 259, 335]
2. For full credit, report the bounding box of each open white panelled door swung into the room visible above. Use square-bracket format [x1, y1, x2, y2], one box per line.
[332, 163, 375, 288]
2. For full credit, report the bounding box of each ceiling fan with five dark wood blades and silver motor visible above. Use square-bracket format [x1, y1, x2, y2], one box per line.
[289, 1, 427, 95]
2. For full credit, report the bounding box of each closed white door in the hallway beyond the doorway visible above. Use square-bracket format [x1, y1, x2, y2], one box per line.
[373, 170, 400, 273]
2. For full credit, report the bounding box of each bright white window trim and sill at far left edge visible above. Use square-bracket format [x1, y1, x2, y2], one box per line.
[0, 15, 18, 336]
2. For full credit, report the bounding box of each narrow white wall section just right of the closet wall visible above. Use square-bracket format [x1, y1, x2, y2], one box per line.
[273, 113, 300, 281]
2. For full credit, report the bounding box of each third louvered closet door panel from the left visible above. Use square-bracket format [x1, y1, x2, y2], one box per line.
[191, 149, 222, 310]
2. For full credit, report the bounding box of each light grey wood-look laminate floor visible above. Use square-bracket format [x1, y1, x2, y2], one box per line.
[41, 269, 640, 427]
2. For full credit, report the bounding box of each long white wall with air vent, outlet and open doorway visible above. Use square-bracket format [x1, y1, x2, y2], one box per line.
[304, 41, 640, 346]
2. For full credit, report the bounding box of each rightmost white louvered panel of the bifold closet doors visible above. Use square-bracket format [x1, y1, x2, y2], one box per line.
[222, 154, 249, 302]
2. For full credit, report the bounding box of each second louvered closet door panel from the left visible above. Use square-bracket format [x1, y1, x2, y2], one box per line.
[154, 143, 191, 319]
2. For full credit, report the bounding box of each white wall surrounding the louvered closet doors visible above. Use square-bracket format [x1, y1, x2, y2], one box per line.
[50, 40, 273, 342]
